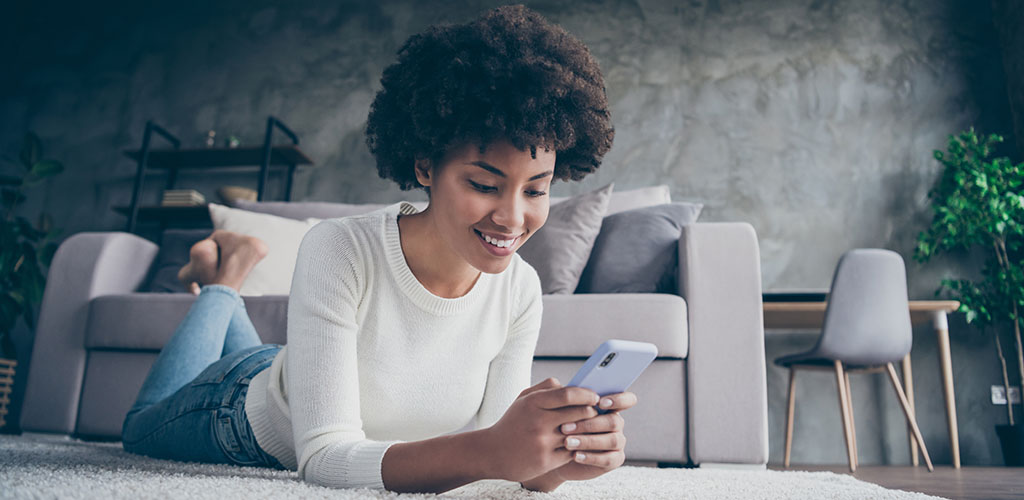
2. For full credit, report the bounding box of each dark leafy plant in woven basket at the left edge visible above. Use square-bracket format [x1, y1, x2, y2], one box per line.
[0, 132, 63, 428]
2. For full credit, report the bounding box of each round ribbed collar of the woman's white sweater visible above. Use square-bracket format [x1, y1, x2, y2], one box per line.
[383, 202, 490, 316]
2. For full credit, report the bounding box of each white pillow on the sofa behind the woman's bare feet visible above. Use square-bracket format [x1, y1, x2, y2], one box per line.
[209, 203, 321, 295]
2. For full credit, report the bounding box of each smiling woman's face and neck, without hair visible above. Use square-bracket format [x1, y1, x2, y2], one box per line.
[398, 140, 556, 290]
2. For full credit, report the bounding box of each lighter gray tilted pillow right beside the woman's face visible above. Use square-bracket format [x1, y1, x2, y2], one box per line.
[519, 184, 613, 294]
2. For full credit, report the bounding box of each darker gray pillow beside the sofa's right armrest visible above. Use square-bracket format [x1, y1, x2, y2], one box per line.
[575, 202, 703, 293]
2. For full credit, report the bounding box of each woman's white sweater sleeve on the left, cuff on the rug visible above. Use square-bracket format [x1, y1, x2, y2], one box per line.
[286, 220, 399, 490]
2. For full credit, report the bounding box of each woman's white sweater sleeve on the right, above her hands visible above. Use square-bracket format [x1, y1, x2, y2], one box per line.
[476, 261, 544, 429]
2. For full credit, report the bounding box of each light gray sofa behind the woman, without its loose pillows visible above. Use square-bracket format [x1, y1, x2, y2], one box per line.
[20, 217, 768, 465]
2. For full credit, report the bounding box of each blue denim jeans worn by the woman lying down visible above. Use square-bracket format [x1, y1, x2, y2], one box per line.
[121, 285, 286, 469]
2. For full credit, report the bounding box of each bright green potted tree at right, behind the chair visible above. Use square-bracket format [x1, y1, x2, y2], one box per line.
[913, 128, 1024, 465]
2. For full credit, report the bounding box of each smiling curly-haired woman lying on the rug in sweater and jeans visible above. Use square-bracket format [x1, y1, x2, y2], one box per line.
[123, 6, 636, 493]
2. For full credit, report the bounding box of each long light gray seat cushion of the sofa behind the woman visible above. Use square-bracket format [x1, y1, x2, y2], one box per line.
[85, 293, 688, 358]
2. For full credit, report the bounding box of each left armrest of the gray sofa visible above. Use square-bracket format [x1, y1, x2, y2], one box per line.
[20, 233, 159, 433]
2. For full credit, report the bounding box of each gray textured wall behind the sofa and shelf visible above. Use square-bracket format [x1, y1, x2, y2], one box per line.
[0, 0, 1012, 464]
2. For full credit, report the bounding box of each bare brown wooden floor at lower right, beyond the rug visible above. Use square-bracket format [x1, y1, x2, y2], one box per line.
[768, 465, 1024, 500]
